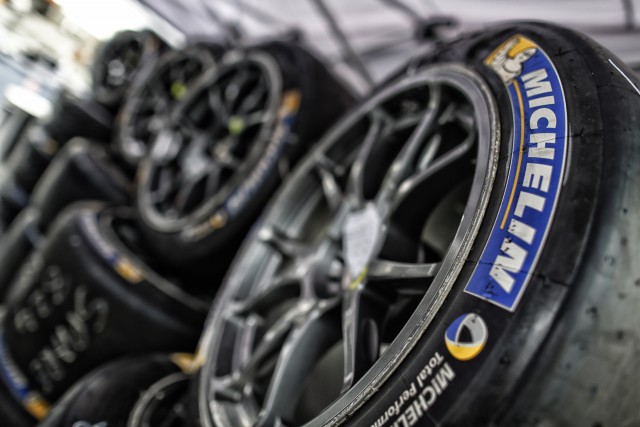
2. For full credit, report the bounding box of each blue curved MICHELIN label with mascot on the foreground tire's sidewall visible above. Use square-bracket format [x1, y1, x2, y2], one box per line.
[465, 35, 568, 311]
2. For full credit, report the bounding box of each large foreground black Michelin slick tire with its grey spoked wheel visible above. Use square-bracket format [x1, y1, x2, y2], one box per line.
[198, 22, 640, 427]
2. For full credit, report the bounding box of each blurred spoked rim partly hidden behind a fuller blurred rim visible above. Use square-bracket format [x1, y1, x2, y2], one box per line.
[120, 48, 214, 164]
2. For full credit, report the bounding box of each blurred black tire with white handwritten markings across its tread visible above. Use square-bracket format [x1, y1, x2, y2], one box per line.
[2, 204, 208, 403]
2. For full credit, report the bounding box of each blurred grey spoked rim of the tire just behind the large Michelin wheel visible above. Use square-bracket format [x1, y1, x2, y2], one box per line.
[138, 53, 282, 232]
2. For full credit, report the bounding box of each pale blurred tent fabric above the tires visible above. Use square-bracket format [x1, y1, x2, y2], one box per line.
[139, 0, 640, 91]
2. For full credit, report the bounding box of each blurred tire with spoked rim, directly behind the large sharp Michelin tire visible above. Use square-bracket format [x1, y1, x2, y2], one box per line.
[136, 42, 352, 277]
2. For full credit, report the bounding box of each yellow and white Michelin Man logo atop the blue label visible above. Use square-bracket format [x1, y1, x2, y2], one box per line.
[485, 36, 538, 86]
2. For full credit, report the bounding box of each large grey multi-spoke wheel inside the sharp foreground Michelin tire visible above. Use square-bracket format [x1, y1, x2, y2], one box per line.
[199, 64, 499, 427]
